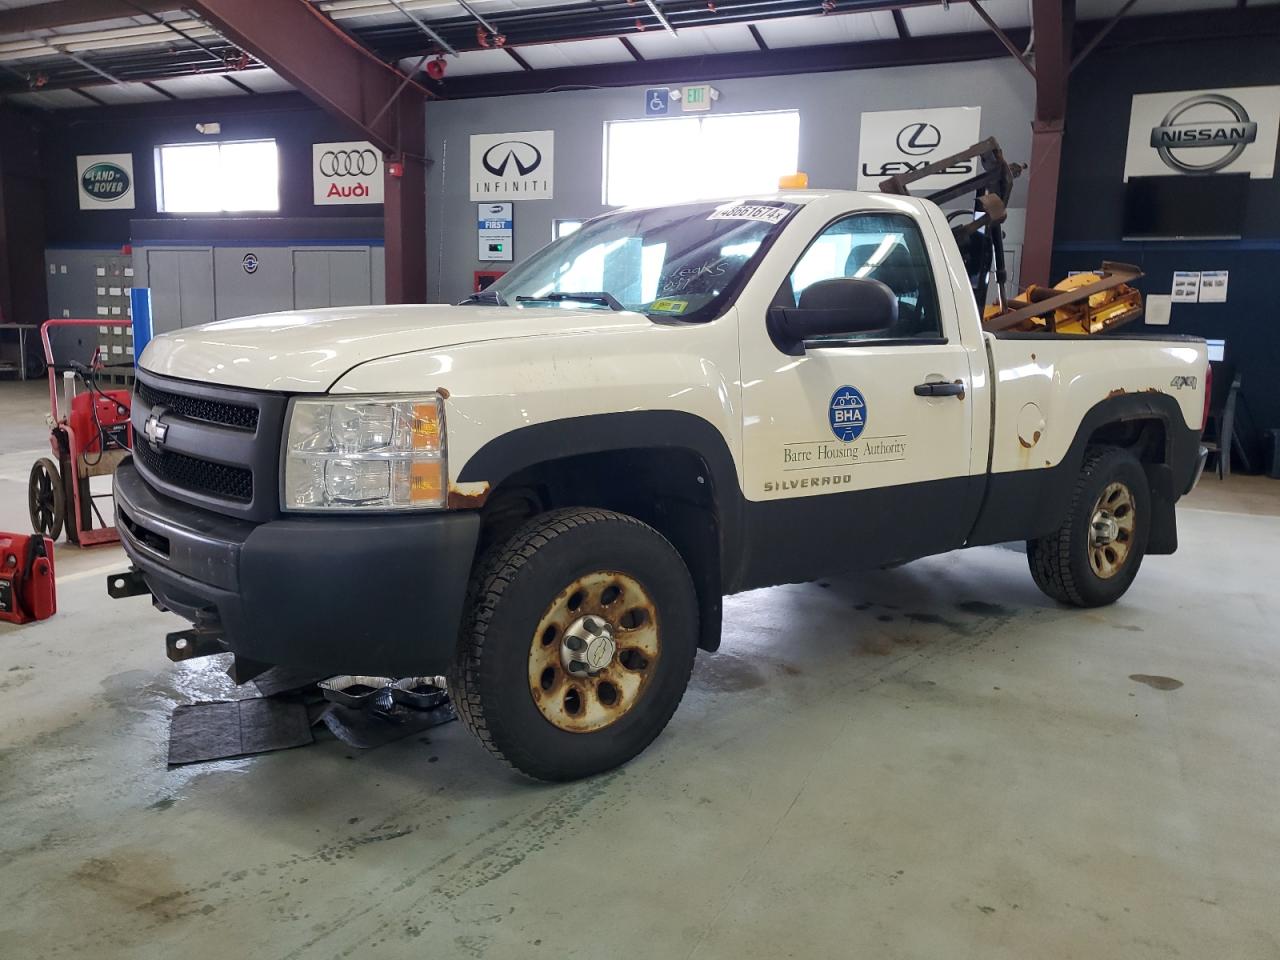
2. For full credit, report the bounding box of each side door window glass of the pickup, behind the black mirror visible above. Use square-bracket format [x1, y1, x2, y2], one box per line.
[783, 214, 942, 339]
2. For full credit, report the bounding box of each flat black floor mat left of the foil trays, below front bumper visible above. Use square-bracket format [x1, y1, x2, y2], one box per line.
[169, 698, 315, 767]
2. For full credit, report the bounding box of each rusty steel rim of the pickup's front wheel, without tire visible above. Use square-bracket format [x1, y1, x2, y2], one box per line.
[529, 571, 662, 733]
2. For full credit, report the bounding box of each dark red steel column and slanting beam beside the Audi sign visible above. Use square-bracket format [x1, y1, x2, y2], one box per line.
[189, 0, 433, 303]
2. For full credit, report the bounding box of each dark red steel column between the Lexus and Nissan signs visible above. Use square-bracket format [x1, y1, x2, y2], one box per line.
[1019, 0, 1075, 287]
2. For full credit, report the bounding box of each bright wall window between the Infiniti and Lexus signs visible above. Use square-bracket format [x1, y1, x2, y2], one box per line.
[604, 110, 800, 206]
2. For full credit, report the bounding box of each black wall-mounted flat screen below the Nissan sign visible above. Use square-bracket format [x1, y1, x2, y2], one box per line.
[1124, 173, 1249, 239]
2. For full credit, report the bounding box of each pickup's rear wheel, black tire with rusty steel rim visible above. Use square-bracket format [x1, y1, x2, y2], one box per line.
[1027, 447, 1151, 607]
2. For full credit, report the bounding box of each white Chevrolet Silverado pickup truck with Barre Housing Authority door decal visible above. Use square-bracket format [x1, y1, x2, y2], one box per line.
[109, 189, 1208, 780]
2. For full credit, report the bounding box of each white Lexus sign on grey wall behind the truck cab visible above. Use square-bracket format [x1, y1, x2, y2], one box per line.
[858, 106, 982, 191]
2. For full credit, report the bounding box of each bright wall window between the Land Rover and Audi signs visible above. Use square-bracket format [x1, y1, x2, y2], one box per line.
[156, 140, 280, 214]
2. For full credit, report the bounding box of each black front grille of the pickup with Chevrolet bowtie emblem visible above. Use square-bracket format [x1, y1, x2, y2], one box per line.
[131, 369, 289, 522]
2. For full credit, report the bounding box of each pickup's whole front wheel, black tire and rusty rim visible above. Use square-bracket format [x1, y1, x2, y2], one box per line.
[449, 508, 698, 781]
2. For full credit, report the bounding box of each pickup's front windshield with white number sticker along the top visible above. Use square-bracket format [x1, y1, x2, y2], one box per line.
[472, 201, 797, 320]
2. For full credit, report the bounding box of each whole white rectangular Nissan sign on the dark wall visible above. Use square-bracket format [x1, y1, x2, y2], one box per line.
[1124, 87, 1280, 180]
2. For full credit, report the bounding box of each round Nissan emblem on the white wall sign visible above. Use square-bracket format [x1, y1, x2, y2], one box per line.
[1151, 93, 1258, 173]
